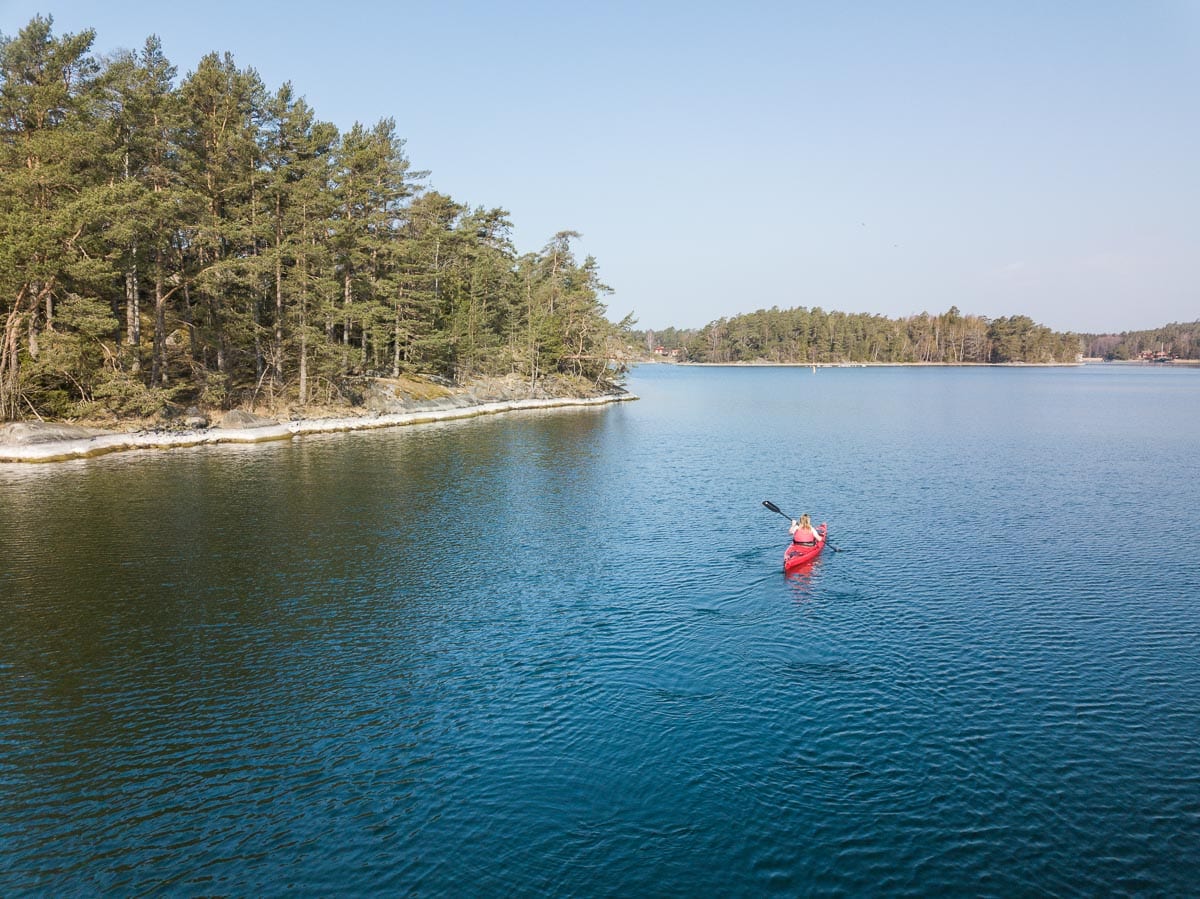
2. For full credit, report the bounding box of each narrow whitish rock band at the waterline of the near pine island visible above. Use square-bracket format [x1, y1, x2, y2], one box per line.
[0, 394, 638, 463]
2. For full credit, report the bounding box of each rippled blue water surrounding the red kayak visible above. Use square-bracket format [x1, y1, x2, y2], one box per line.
[0, 366, 1200, 897]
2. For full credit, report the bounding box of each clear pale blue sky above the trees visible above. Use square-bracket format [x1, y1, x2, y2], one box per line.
[0, 0, 1200, 331]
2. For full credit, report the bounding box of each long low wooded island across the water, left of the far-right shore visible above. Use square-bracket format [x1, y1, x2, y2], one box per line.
[637, 306, 1082, 364]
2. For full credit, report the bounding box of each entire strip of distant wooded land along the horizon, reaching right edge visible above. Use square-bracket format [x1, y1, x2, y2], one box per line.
[631, 306, 1200, 365]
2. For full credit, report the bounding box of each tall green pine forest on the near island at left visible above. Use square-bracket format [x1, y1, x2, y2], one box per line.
[0, 17, 619, 420]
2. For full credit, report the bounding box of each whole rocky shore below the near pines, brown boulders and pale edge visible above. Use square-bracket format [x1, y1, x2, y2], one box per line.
[0, 378, 637, 462]
